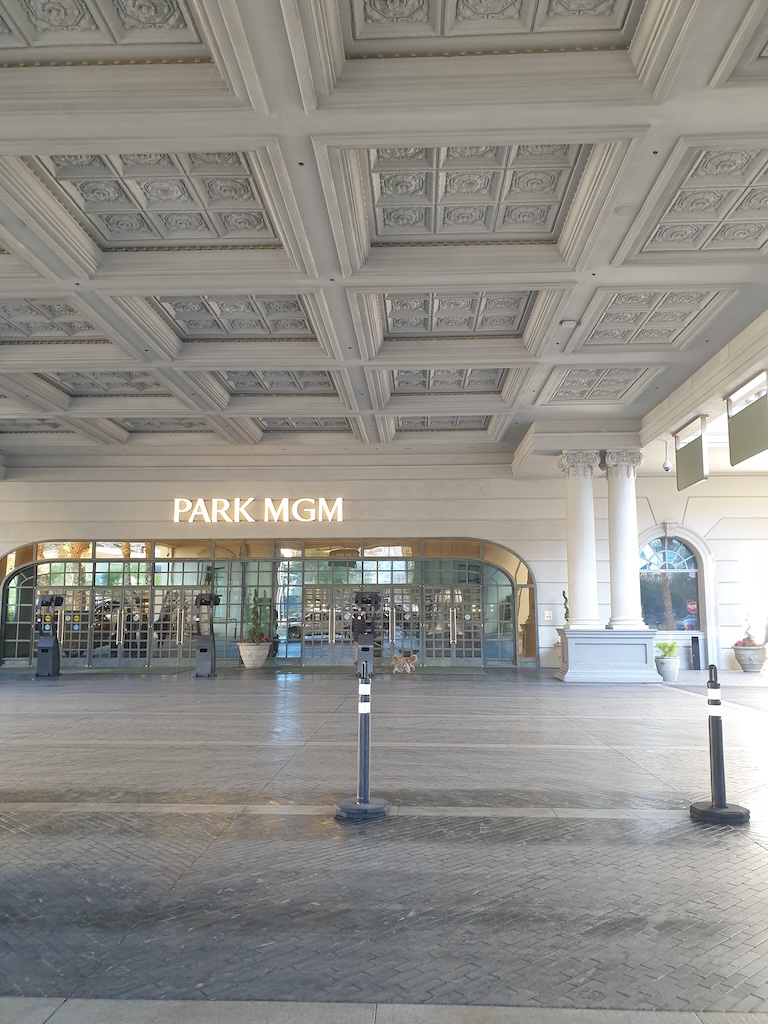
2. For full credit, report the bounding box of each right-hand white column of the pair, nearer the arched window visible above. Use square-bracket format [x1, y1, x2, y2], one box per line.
[605, 451, 647, 630]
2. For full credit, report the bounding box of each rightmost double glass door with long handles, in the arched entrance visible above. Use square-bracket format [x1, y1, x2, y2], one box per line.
[422, 585, 482, 667]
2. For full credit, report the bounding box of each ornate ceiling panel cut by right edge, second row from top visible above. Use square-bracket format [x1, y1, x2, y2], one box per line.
[642, 148, 768, 253]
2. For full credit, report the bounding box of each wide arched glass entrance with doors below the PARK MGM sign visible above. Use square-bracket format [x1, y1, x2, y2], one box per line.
[2, 540, 538, 668]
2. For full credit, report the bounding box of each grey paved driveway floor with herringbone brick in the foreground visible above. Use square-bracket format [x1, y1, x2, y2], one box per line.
[0, 668, 768, 1024]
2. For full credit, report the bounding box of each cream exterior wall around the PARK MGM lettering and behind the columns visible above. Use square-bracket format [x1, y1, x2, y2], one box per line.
[0, 462, 768, 668]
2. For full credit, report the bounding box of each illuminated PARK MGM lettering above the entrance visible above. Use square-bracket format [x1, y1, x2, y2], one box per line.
[173, 498, 344, 522]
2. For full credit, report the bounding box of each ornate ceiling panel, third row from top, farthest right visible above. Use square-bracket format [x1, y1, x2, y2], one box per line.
[574, 289, 727, 348]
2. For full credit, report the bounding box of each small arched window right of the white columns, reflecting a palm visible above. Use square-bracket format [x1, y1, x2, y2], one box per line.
[640, 537, 700, 631]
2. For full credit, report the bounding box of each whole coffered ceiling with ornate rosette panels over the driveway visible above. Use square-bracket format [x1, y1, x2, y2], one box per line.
[0, 0, 768, 475]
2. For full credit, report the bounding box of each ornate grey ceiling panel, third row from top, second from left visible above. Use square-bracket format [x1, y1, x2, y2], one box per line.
[154, 295, 314, 340]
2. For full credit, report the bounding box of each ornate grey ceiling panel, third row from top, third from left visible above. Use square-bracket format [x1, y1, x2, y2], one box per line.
[382, 291, 538, 338]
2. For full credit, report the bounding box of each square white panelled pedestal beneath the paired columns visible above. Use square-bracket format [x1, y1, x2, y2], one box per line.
[555, 627, 662, 683]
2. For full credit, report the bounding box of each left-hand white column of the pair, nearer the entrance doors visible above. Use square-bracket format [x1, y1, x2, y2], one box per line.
[557, 452, 600, 630]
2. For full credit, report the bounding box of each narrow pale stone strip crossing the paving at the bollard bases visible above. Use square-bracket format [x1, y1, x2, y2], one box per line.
[0, 803, 689, 819]
